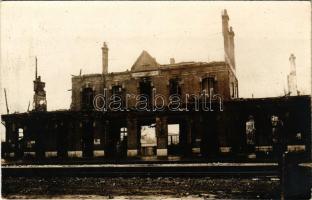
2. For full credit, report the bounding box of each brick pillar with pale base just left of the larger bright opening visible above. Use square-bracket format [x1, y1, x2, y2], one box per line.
[127, 115, 138, 157]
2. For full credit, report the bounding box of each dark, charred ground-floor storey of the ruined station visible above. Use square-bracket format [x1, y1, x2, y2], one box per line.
[2, 96, 311, 159]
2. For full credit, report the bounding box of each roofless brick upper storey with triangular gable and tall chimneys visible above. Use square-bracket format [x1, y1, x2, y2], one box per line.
[71, 10, 238, 111]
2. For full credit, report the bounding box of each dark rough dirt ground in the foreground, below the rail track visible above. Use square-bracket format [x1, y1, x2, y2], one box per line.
[2, 177, 279, 199]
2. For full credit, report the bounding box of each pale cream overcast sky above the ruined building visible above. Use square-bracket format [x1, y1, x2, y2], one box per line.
[0, 1, 311, 113]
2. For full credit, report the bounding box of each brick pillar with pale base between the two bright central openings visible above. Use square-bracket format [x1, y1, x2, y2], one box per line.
[156, 117, 168, 156]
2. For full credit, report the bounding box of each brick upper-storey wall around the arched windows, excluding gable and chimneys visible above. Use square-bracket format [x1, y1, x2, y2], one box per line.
[71, 62, 234, 111]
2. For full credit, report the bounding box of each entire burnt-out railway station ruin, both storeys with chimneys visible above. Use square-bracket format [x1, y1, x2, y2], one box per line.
[2, 10, 311, 159]
